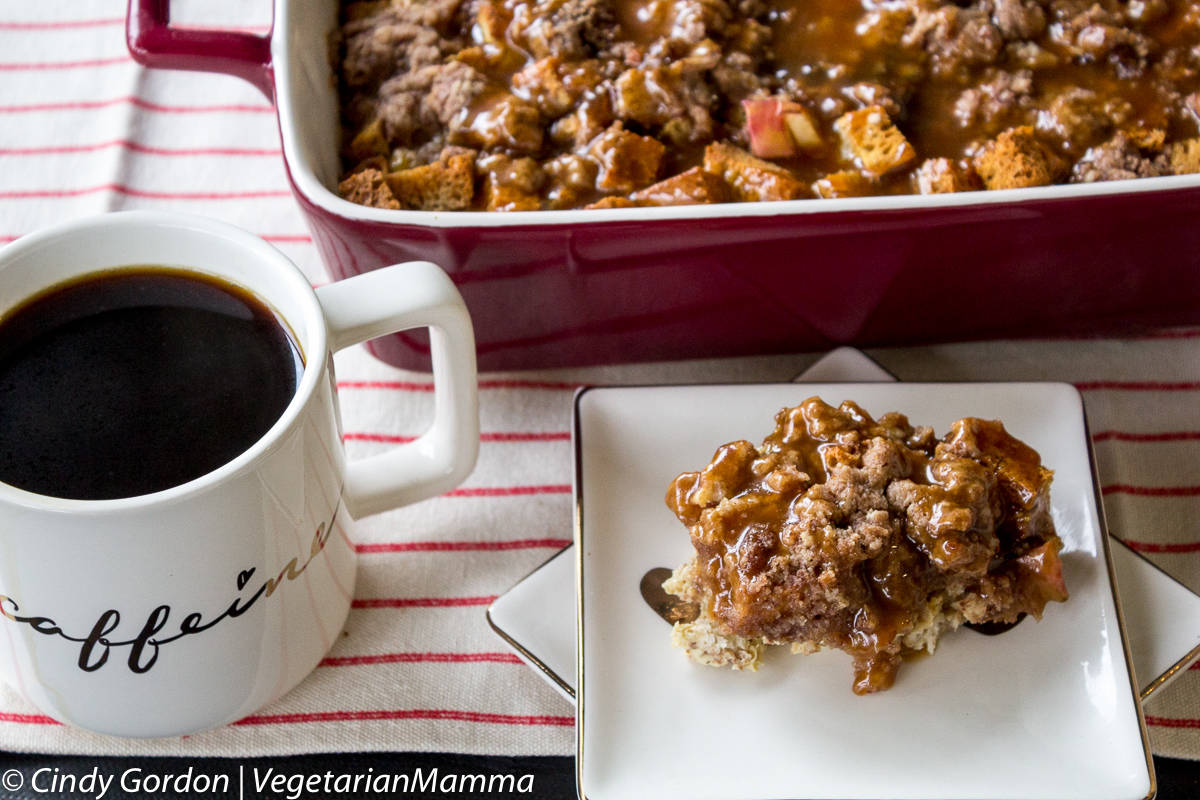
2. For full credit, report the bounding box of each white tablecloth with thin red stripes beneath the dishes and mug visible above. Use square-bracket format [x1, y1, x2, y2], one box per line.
[0, 0, 1200, 758]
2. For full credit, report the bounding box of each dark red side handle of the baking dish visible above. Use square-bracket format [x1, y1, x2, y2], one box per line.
[125, 0, 275, 100]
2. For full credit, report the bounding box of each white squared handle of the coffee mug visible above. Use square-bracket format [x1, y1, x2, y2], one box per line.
[317, 261, 479, 517]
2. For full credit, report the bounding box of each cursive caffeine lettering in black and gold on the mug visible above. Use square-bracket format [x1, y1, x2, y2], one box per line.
[0, 507, 337, 673]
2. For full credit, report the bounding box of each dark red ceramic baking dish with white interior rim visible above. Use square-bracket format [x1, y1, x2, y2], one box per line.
[127, 0, 1200, 369]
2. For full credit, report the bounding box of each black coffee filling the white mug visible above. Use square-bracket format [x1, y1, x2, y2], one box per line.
[0, 266, 304, 500]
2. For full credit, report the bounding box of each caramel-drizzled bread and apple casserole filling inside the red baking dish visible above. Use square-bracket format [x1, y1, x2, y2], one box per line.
[334, 0, 1200, 211]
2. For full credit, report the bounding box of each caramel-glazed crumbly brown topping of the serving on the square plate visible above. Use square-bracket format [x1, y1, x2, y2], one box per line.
[667, 398, 1067, 693]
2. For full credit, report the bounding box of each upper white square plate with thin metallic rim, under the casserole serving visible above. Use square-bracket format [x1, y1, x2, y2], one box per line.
[575, 384, 1153, 800]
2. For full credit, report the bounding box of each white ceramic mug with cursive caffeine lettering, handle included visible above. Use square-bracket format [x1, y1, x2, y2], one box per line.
[0, 212, 479, 736]
